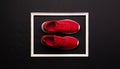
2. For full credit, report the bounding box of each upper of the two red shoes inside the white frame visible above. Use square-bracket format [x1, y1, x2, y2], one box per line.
[42, 19, 80, 34]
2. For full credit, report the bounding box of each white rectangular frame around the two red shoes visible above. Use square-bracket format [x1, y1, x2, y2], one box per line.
[31, 12, 89, 57]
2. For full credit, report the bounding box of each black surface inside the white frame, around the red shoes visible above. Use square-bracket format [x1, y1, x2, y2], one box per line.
[34, 15, 85, 54]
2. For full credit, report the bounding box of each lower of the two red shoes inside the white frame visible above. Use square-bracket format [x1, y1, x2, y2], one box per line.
[41, 35, 79, 50]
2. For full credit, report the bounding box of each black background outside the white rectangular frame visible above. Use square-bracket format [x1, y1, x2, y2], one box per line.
[1, 0, 120, 69]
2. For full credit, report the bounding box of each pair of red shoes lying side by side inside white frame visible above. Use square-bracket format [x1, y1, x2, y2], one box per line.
[41, 19, 80, 50]
